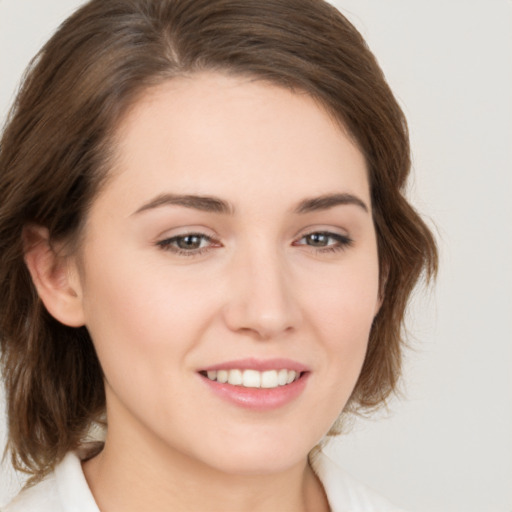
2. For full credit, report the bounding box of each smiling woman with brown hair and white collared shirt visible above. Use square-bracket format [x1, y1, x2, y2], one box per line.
[0, 0, 437, 512]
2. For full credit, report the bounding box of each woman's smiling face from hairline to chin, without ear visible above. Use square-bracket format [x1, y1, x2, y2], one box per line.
[73, 74, 379, 474]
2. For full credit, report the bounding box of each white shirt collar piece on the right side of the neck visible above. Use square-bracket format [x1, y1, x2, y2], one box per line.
[311, 452, 404, 512]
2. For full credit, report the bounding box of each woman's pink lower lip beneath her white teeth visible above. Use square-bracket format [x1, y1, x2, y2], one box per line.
[200, 372, 309, 411]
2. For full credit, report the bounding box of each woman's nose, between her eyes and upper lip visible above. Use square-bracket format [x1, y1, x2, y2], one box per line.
[224, 243, 302, 340]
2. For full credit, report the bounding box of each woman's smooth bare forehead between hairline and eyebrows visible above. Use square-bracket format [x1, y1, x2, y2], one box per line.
[99, 73, 369, 211]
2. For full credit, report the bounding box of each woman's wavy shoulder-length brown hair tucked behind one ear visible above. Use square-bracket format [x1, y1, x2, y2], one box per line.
[0, 0, 437, 476]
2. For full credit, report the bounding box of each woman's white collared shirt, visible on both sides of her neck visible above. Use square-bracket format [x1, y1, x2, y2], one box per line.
[2, 452, 403, 512]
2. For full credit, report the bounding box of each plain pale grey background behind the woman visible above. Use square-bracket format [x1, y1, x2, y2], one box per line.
[0, 0, 512, 512]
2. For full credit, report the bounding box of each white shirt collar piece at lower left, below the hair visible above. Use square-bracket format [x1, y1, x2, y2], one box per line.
[1, 452, 99, 512]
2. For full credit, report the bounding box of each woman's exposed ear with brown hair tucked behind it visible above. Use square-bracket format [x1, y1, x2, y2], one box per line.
[23, 225, 85, 327]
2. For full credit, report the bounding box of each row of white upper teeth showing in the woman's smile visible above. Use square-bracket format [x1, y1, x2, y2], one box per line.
[206, 369, 300, 389]
